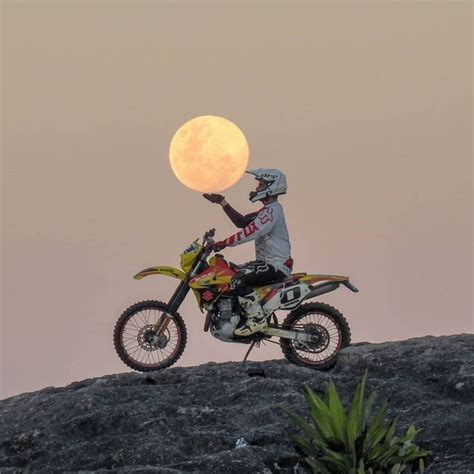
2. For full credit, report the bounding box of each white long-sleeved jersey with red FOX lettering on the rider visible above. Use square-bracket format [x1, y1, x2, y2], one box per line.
[219, 201, 291, 275]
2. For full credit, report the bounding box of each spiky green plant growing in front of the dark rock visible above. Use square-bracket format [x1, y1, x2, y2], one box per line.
[281, 371, 431, 474]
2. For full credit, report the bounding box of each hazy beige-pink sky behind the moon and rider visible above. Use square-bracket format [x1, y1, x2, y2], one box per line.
[0, 0, 473, 398]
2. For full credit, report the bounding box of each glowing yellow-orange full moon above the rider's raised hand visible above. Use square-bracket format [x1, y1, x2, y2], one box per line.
[170, 115, 249, 193]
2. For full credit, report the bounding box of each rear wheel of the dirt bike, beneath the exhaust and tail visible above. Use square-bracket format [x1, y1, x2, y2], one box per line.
[280, 303, 351, 370]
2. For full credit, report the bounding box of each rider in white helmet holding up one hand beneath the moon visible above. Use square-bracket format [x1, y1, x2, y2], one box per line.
[203, 168, 293, 336]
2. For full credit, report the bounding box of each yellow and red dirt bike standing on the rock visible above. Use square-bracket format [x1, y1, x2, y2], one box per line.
[114, 229, 359, 372]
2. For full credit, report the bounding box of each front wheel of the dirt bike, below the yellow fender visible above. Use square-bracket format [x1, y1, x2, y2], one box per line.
[114, 300, 187, 372]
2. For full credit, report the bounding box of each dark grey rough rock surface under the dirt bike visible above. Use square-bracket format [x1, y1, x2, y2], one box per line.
[0, 334, 474, 473]
